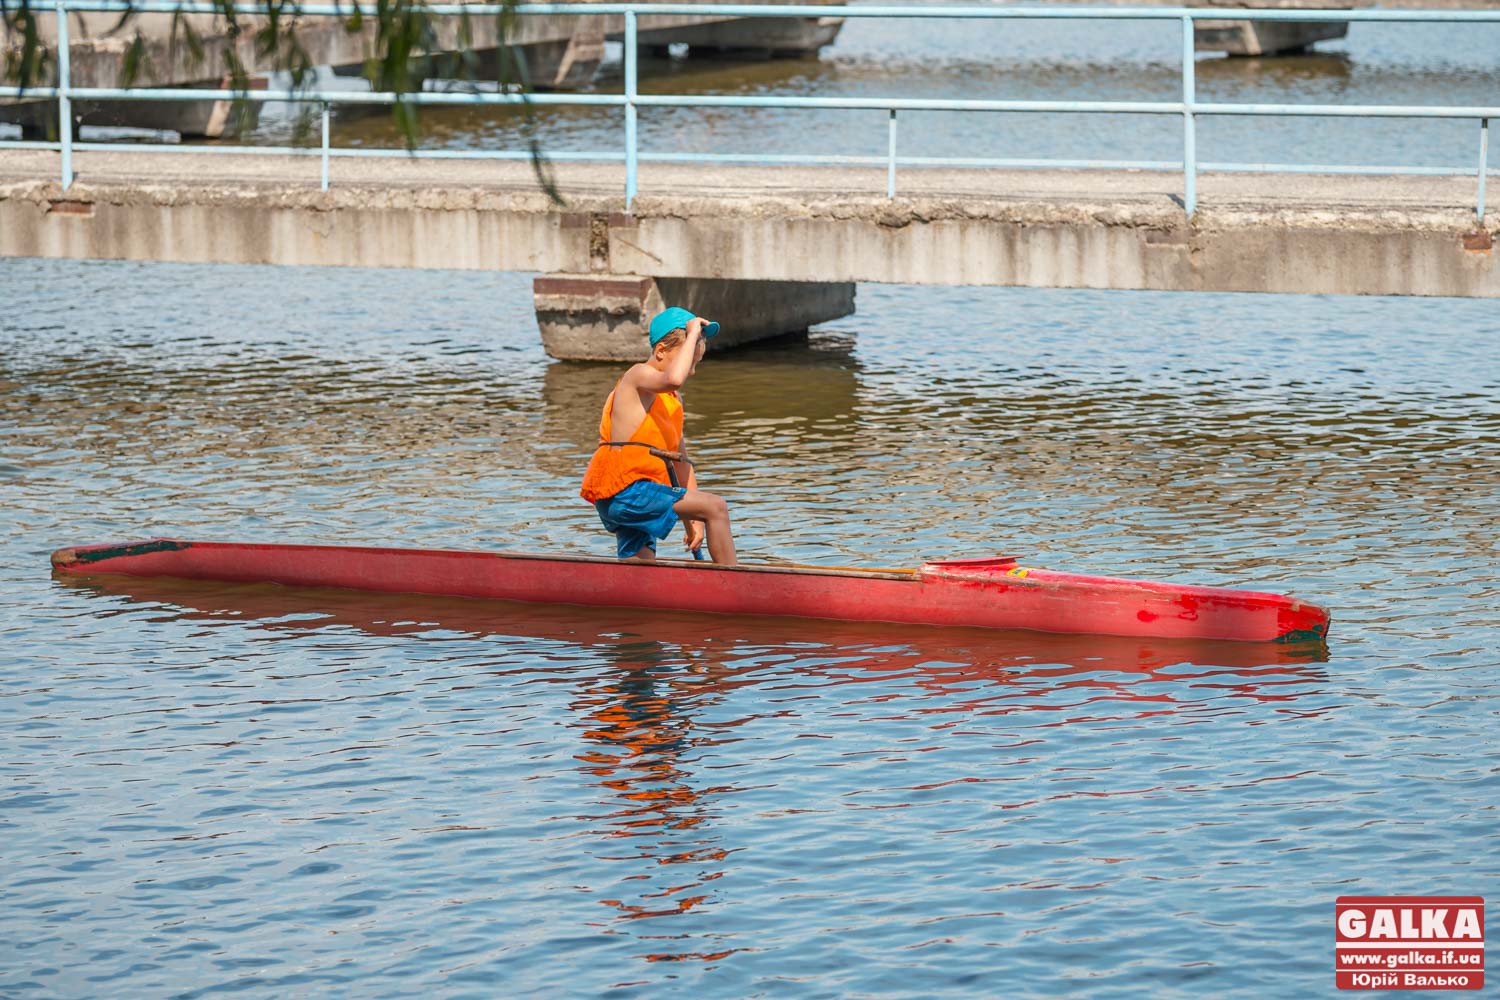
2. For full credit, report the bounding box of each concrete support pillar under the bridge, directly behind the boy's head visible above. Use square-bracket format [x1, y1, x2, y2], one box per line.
[531, 274, 855, 361]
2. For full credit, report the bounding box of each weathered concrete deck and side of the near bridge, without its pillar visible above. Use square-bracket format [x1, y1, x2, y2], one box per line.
[0, 153, 1500, 297]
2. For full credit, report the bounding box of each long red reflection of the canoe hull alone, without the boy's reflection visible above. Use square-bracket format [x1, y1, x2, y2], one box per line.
[53, 573, 1328, 677]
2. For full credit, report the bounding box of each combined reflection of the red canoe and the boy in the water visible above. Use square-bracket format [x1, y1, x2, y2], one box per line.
[54, 576, 1328, 963]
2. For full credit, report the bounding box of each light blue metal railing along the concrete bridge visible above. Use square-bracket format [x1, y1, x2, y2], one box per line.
[0, 0, 1500, 225]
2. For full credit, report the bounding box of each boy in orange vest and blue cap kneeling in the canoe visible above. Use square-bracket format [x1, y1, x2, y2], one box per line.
[579, 306, 735, 565]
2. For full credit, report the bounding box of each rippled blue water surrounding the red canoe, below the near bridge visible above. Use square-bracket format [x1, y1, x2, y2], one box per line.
[0, 261, 1500, 997]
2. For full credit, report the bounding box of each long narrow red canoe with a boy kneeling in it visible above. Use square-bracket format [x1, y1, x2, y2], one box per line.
[53, 538, 1329, 642]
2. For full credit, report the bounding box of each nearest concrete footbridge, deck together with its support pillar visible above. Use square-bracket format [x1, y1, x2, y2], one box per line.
[0, 150, 1500, 358]
